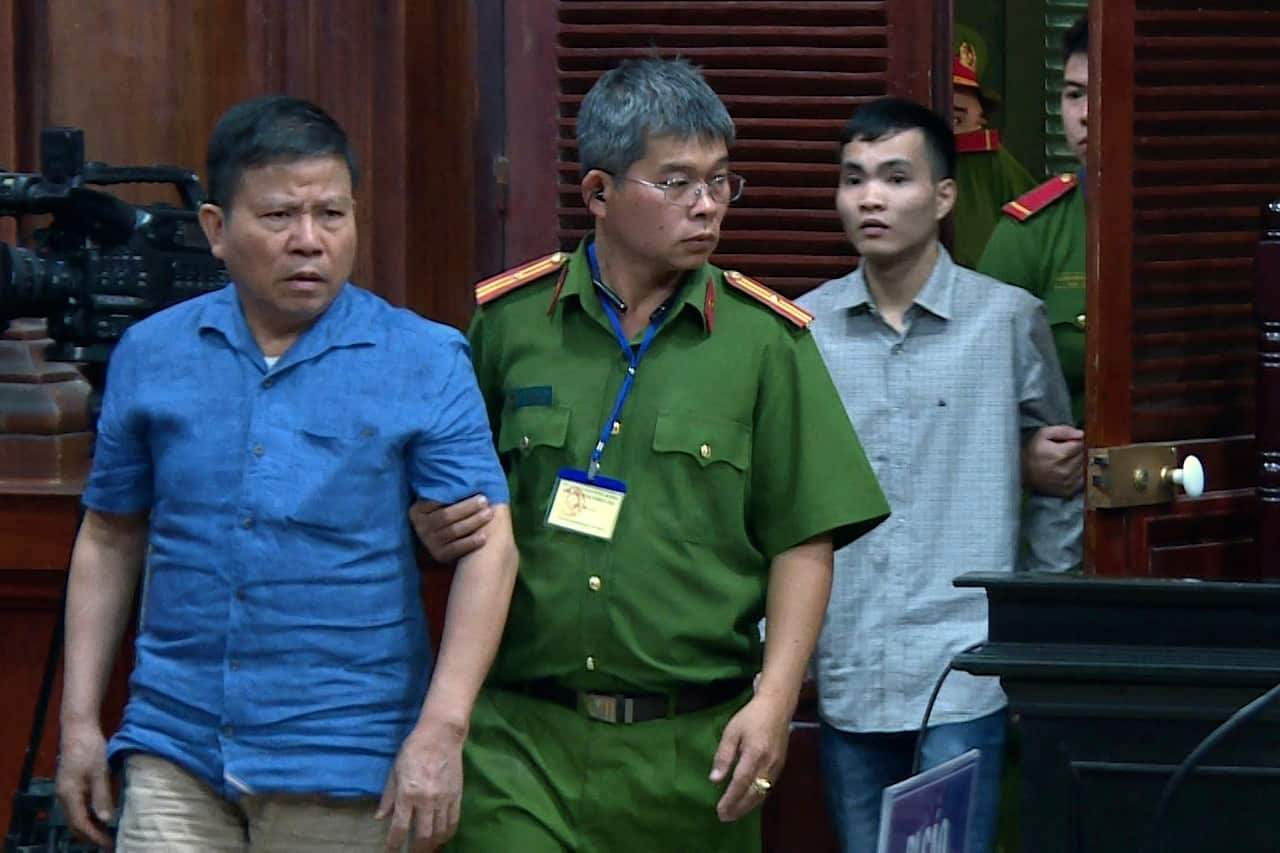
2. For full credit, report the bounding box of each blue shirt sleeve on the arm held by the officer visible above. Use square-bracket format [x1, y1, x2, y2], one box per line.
[408, 332, 509, 503]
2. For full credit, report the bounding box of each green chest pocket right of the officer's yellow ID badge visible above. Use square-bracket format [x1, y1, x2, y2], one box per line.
[650, 411, 751, 542]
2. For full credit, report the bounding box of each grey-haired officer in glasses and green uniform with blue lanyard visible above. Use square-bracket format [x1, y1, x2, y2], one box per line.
[413, 59, 888, 853]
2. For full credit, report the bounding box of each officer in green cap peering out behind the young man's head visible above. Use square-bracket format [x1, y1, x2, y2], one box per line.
[951, 41, 1036, 269]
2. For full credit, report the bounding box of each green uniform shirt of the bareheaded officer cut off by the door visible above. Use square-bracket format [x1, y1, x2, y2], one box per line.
[978, 187, 1085, 427]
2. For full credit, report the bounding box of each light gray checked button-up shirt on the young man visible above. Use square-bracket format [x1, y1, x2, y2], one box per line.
[800, 250, 1084, 731]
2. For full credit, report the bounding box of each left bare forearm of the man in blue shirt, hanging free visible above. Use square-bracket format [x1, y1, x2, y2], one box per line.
[61, 510, 147, 726]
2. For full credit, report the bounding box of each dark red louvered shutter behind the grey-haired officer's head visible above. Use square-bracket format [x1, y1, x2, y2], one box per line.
[508, 0, 945, 296]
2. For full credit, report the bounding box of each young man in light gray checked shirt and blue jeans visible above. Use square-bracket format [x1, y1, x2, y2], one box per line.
[800, 99, 1083, 853]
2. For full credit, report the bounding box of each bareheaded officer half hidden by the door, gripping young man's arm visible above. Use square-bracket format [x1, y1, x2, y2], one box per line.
[978, 18, 1089, 496]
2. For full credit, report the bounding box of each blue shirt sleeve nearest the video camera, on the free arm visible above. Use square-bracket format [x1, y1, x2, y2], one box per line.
[83, 326, 155, 514]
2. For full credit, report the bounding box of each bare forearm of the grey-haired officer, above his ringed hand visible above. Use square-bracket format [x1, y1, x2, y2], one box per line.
[756, 535, 833, 713]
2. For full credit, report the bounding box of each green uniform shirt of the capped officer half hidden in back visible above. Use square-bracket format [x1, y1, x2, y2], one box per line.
[951, 149, 1036, 269]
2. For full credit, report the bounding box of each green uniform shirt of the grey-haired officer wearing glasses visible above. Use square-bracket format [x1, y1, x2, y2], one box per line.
[470, 242, 888, 692]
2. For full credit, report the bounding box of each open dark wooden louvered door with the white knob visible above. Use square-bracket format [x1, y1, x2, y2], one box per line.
[1087, 0, 1280, 576]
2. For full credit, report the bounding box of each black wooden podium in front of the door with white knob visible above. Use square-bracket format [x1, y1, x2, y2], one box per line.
[955, 574, 1280, 853]
